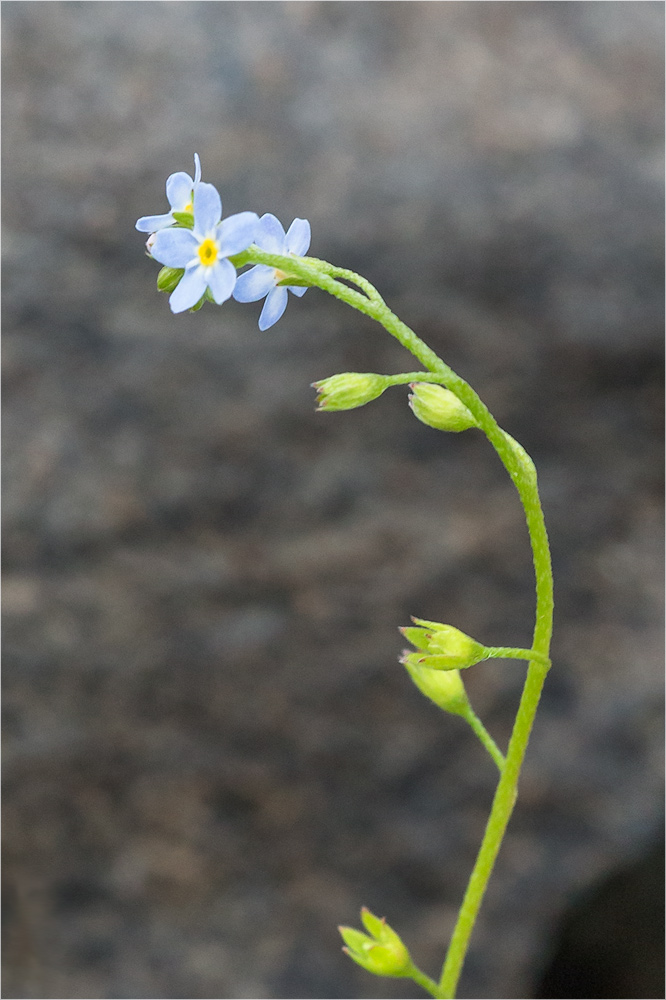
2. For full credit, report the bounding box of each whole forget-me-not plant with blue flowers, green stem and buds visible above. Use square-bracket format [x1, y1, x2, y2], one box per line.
[136, 156, 553, 998]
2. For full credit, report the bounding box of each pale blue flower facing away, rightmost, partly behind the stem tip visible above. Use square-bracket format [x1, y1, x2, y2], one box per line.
[234, 214, 310, 330]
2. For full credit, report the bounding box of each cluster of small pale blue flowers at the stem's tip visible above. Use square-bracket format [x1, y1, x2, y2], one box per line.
[136, 153, 310, 322]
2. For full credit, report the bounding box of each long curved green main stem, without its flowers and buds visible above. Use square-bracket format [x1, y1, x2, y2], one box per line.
[231, 246, 553, 1000]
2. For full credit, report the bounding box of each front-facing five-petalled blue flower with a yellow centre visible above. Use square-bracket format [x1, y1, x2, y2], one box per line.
[150, 182, 259, 313]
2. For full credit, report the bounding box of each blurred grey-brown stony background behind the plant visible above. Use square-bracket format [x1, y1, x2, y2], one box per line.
[2, 2, 664, 998]
